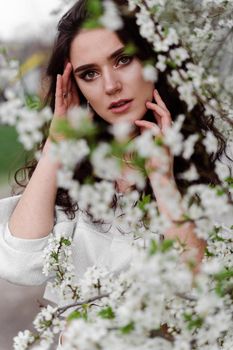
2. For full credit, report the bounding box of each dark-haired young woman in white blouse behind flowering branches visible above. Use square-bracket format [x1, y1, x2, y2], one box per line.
[0, 0, 228, 302]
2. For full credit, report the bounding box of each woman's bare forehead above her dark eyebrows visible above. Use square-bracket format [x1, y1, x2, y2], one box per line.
[70, 28, 124, 65]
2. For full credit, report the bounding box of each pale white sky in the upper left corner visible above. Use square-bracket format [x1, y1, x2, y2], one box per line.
[0, 0, 60, 40]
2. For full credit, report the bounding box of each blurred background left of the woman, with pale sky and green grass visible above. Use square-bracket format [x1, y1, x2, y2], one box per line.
[0, 0, 61, 350]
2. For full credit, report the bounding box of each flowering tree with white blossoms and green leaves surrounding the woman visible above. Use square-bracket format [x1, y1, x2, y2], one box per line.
[0, 0, 233, 350]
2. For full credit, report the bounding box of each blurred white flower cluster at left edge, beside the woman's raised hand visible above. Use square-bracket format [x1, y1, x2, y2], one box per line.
[0, 49, 52, 150]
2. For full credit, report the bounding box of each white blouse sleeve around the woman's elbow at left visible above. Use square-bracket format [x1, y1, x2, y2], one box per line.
[0, 196, 74, 285]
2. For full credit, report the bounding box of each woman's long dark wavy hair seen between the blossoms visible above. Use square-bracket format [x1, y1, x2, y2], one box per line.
[15, 0, 231, 218]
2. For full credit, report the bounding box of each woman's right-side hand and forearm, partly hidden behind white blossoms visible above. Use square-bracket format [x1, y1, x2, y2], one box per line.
[135, 90, 206, 274]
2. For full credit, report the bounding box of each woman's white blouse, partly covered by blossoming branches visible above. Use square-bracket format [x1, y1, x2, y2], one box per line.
[0, 196, 133, 302]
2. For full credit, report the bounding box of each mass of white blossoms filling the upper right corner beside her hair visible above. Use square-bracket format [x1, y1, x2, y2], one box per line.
[129, 1, 232, 137]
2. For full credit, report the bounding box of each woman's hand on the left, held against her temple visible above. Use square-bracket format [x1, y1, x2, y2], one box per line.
[49, 62, 80, 142]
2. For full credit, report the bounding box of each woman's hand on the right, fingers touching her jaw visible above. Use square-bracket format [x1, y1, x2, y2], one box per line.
[135, 89, 174, 179]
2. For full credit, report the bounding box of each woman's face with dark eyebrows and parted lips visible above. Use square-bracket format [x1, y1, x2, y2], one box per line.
[70, 29, 154, 124]
